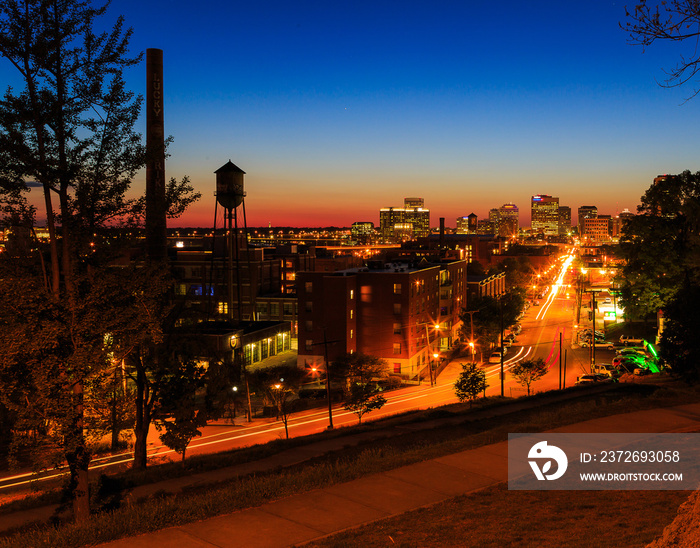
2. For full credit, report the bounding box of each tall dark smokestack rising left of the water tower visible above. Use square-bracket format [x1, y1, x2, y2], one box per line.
[146, 48, 167, 261]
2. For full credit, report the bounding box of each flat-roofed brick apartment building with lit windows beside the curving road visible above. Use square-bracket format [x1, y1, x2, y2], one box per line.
[297, 260, 467, 378]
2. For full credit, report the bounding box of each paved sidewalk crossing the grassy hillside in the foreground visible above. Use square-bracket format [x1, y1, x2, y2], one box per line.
[95, 403, 700, 548]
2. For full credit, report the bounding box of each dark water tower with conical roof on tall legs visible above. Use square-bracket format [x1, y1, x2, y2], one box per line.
[214, 160, 252, 323]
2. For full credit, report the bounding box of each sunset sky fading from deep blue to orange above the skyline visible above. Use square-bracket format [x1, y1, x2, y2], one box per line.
[8, 0, 700, 226]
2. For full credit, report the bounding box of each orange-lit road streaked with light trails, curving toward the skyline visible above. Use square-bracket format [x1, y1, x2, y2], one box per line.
[0, 247, 612, 493]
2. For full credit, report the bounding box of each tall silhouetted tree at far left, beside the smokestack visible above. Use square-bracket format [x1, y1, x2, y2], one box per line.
[0, 0, 144, 519]
